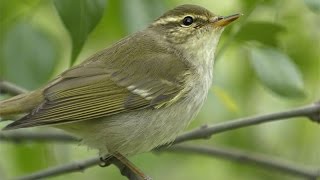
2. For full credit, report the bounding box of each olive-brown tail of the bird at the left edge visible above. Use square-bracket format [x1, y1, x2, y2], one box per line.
[0, 90, 43, 118]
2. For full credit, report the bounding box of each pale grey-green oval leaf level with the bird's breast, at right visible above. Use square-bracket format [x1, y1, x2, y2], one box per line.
[250, 47, 305, 98]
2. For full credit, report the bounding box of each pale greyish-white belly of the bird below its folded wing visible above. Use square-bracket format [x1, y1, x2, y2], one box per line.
[62, 82, 208, 156]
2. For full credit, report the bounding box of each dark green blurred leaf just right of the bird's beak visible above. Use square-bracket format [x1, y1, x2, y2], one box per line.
[236, 22, 285, 46]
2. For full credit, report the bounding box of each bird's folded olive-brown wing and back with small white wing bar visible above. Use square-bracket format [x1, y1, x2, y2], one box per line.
[5, 35, 190, 129]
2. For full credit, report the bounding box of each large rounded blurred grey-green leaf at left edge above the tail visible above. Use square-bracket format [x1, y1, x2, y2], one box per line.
[0, 22, 58, 89]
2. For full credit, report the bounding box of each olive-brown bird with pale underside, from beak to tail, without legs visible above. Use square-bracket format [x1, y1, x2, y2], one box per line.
[0, 5, 239, 155]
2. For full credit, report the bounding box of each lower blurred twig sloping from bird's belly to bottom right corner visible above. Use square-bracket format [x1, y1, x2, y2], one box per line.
[166, 144, 320, 179]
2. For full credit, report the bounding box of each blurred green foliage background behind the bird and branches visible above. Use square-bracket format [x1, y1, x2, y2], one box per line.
[0, 0, 320, 180]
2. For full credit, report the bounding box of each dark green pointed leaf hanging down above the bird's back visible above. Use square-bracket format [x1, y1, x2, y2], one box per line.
[54, 0, 106, 65]
